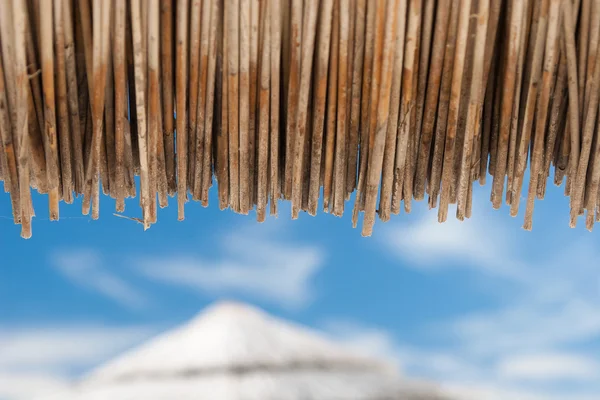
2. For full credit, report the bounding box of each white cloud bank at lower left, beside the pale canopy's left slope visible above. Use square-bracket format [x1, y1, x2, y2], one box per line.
[0, 324, 157, 400]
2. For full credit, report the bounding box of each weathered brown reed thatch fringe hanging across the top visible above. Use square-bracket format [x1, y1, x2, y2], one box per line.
[0, 0, 600, 237]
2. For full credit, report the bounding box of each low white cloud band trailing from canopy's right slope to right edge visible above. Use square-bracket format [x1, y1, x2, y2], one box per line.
[321, 319, 600, 400]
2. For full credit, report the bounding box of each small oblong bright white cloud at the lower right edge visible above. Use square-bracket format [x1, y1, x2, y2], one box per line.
[497, 354, 600, 381]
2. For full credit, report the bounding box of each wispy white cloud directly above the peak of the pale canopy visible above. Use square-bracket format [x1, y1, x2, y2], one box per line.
[137, 227, 323, 307]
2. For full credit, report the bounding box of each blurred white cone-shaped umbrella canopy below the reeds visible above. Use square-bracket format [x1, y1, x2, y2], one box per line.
[39, 303, 448, 400]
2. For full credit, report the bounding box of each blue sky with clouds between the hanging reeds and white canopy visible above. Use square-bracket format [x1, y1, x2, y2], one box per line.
[0, 179, 600, 400]
